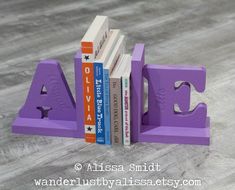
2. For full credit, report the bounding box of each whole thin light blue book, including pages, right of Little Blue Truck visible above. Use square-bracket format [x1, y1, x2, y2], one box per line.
[103, 35, 125, 145]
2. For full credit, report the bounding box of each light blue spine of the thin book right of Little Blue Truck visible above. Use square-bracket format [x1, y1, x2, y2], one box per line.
[103, 69, 111, 145]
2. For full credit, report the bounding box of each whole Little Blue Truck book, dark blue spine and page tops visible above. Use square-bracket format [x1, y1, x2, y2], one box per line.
[94, 29, 120, 144]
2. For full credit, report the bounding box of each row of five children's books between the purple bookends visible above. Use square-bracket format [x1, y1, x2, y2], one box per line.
[81, 16, 131, 145]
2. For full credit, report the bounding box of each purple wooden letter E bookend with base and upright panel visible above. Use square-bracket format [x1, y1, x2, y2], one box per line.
[131, 44, 210, 145]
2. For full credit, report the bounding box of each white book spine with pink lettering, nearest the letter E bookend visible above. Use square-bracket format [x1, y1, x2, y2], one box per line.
[122, 77, 131, 145]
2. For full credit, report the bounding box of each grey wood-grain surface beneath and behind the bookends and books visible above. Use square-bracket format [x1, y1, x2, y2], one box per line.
[0, 0, 235, 190]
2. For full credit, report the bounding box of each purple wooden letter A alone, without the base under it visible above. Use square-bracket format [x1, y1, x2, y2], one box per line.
[19, 60, 76, 121]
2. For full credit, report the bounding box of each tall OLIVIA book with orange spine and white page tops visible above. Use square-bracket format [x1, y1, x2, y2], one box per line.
[81, 16, 109, 143]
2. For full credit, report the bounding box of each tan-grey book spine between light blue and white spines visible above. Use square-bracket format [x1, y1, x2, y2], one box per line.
[110, 78, 122, 144]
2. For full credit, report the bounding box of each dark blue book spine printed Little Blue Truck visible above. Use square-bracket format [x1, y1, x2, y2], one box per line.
[94, 63, 105, 144]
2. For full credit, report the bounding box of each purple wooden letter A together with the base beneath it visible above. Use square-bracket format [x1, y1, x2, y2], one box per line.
[12, 60, 84, 137]
